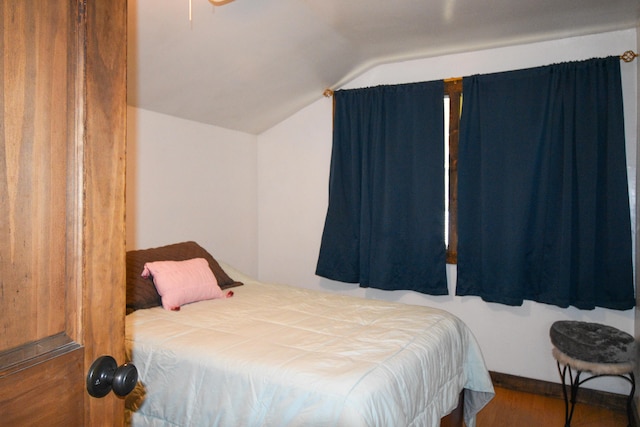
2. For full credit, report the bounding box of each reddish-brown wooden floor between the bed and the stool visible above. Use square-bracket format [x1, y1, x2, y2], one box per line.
[476, 387, 627, 427]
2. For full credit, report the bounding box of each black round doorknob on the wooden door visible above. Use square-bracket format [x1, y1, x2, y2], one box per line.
[87, 356, 138, 397]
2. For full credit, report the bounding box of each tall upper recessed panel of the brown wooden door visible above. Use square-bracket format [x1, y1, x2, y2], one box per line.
[0, 1, 73, 352]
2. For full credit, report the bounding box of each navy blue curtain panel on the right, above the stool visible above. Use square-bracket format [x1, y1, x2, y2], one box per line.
[456, 57, 635, 310]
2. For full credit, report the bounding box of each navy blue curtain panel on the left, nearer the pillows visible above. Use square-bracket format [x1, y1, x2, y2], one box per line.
[316, 81, 448, 295]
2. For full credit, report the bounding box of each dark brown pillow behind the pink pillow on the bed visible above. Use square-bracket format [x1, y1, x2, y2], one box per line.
[127, 242, 242, 314]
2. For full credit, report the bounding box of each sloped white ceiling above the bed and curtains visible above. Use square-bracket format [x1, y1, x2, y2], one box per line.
[128, 0, 640, 134]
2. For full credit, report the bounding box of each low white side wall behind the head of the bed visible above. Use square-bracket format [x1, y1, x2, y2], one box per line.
[126, 107, 258, 274]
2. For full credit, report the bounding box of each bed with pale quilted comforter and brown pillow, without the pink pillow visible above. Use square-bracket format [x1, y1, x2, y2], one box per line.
[126, 242, 494, 427]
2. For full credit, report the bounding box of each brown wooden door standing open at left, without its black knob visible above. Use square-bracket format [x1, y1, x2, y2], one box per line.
[0, 0, 126, 426]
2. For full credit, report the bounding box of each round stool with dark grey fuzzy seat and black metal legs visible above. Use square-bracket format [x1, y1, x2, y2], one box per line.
[549, 320, 636, 427]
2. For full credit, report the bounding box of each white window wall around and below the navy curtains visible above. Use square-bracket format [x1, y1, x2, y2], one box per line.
[258, 30, 637, 394]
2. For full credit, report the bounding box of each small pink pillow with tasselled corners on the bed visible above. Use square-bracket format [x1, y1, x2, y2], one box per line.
[142, 258, 224, 310]
